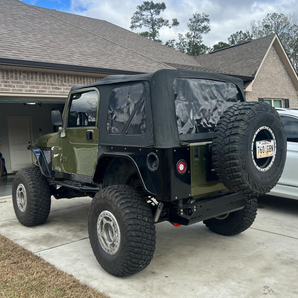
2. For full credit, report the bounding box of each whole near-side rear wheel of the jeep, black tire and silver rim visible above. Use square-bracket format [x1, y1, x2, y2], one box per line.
[88, 185, 156, 277]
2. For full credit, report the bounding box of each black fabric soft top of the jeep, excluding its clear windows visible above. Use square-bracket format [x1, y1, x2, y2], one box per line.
[71, 69, 244, 148]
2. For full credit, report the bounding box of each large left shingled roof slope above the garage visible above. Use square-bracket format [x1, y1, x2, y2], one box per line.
[0, 0, 199, 72]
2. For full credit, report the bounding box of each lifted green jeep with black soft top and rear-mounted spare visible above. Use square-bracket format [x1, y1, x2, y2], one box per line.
[13, 70, 287, 277]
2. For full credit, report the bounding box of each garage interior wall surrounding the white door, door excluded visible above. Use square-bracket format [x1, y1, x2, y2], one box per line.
[0, 103, 64, 173]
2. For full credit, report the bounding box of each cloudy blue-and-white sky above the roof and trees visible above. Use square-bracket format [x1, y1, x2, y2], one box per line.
[69, 0, 298, 46]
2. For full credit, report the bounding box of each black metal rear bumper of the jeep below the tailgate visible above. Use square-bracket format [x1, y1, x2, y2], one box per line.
[168, 194, 248, 225]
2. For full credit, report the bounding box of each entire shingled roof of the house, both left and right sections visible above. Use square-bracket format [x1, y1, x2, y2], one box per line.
[0, 0, 274, 78]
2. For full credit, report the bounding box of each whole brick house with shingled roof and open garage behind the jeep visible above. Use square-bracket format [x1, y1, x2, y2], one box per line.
[0, 0, 298, 173]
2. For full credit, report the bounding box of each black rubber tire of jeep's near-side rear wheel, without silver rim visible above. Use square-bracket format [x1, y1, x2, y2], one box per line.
[89, 185, 156, 277]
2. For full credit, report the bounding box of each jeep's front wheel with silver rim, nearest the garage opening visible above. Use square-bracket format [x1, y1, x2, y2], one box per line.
[12, 167, 51, 227]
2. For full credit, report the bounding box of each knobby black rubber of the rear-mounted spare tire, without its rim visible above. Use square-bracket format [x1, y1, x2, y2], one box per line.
[212, 102, 282, 197]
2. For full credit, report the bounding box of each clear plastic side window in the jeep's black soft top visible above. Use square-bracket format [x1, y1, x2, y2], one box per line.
[107, 83, 146, 134]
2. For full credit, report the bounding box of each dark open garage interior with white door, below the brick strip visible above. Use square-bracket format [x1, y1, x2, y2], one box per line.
[0, 97, 64, 173]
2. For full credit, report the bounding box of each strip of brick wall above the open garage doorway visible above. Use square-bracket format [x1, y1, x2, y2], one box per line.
[0, 69, 101, 95]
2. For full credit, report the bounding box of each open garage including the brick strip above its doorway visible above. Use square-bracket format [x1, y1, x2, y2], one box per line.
[0, 65, 103, 175]
